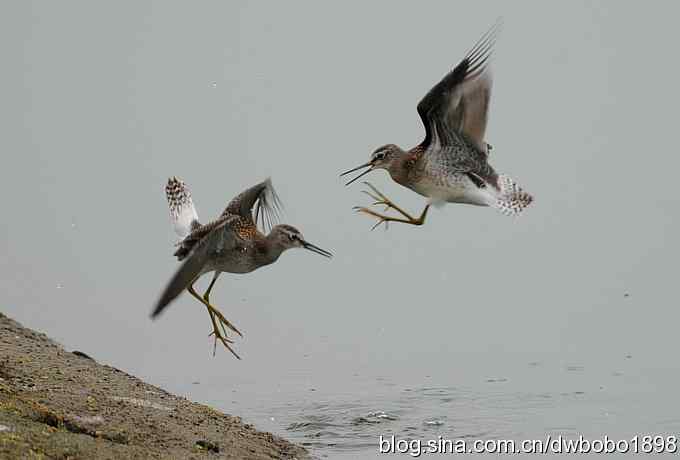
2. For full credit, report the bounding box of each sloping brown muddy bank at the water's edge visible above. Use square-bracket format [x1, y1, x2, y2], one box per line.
[0, 313, 309, 460]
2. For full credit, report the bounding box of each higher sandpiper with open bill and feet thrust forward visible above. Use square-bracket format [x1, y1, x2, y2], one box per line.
[341, 22, 533, 228]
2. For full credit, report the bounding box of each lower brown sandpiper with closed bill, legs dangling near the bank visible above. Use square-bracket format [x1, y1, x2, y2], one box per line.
[151, 177, 331, 359]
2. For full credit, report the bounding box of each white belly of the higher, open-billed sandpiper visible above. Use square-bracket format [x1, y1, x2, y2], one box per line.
[412, 176, 490, 206]
